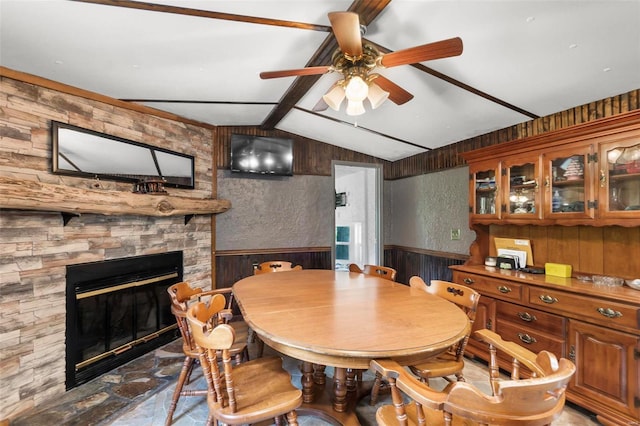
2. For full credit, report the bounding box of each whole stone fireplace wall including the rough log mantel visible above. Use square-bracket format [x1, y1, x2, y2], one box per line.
[0, 70, 224, 423]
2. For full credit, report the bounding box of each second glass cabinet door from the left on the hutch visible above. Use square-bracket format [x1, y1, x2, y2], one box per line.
[502, 156, 541, 219]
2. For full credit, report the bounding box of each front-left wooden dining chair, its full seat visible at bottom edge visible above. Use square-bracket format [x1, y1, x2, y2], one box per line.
[187, 303, 302, 426]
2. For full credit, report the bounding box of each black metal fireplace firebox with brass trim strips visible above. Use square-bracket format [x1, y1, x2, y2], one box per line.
[66, 252, 183, 389]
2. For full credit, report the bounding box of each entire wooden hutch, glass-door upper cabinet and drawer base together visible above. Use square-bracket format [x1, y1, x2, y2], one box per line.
[458, 111, 640, 425]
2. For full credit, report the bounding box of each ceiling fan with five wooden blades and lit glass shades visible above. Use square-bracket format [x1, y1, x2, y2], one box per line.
[260, 12, 462, 115]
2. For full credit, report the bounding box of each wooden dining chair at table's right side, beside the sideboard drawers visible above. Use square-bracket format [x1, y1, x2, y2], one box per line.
[371, 276, 480, 405]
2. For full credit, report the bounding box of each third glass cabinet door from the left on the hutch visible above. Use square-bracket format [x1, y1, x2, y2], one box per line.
[544, 146, 595, 218]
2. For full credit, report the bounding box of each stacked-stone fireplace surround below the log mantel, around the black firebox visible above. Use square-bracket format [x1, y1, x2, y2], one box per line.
[0, 210, 211, 419]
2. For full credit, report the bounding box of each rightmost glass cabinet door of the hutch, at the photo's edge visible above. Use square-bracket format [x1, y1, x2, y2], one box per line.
[600, 138, 640, 217]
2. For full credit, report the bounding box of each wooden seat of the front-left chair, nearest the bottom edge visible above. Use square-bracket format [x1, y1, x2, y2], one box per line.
[208, 357, 302, 424]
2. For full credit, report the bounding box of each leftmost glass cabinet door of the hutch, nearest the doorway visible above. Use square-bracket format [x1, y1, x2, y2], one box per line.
[469, 162, 500, 218]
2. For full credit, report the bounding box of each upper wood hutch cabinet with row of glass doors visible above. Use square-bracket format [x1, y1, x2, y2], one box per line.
[461, 111, 640, 226]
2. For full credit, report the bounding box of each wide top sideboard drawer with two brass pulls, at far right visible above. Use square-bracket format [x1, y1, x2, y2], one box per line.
[529, 287, 640, 331]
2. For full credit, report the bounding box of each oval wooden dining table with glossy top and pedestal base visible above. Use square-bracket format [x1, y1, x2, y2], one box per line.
[233, 269, 470, 425]
